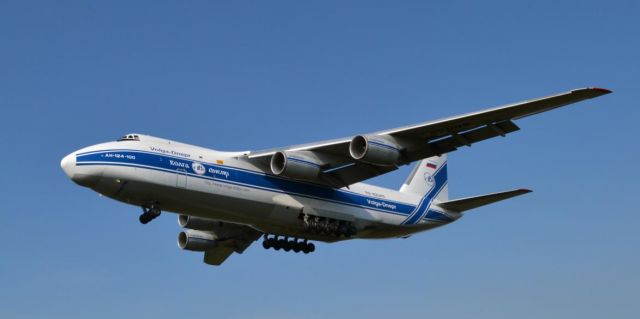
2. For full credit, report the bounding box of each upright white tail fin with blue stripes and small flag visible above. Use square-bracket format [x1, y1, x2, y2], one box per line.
[400, 154, 449, 202]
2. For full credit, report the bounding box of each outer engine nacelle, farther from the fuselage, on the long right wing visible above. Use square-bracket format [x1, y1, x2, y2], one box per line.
[349, 135, 401, 165]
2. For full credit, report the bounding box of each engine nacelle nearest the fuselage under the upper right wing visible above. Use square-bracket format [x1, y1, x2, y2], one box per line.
[271, 152, 321, 180]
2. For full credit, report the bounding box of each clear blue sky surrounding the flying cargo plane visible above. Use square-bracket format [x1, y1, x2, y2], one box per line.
[0, 0, 640, 319]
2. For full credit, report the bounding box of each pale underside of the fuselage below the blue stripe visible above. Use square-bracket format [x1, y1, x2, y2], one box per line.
[94, 166, 436, 241]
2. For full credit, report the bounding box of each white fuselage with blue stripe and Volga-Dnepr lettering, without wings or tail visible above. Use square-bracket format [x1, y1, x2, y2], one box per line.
[61, 135, 460, 241]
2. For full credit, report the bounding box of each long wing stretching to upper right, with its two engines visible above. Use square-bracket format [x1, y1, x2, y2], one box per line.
[244, 88, 611, 187]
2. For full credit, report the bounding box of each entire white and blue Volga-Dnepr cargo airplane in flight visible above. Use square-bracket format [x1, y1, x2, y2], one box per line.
[60, 88, 611, 265]
